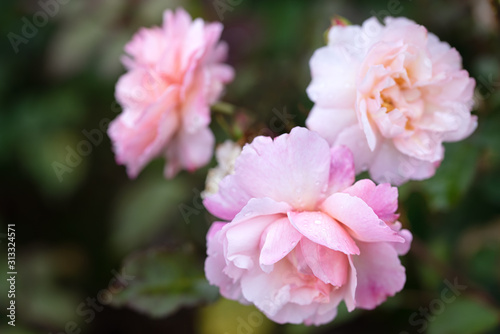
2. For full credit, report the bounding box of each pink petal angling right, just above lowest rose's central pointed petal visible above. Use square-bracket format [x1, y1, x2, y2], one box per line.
[321, 193, 404, 243]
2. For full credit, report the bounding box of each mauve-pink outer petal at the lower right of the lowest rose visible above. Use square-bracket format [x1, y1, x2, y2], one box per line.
[351, 242, 406, 309]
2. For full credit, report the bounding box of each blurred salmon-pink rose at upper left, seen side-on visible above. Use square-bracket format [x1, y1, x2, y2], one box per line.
[108, 9, 234, 178]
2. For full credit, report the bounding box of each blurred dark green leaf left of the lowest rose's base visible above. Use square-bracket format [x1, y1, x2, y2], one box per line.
[112, 249, 217, 317]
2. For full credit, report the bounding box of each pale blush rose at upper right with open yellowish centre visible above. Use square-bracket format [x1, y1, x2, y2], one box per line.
[306, 18, 477, 185]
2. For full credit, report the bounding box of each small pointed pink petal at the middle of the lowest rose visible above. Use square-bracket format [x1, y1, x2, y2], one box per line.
[288, 210, 359, 254]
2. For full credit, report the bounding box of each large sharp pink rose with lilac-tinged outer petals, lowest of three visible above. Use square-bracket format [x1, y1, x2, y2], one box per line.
[204, 128, 412, 325]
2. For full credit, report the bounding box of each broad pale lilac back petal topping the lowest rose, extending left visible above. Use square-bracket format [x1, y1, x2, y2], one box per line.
[204, 127, 330, 220]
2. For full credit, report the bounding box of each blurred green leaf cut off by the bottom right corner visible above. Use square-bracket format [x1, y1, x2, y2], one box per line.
[428, 297, 499, 334]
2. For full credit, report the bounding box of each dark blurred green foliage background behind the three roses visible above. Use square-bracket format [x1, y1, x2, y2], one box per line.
[0, 0, 500, 334]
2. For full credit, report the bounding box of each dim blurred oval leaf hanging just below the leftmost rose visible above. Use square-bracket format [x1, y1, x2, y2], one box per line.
[111, 173, 189, 254]
